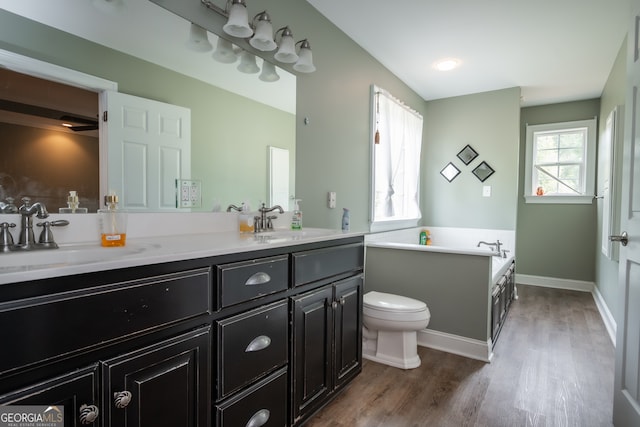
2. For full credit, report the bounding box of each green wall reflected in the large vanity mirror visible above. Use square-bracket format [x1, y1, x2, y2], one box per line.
[0, 10, 296, 211]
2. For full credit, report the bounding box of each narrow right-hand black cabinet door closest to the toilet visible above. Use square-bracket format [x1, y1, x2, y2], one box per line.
[334, 276, 362, 387]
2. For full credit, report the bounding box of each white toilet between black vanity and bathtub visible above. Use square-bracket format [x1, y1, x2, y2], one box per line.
[362, 291, 431, 369]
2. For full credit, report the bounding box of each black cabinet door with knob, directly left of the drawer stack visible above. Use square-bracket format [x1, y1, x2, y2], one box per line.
[102, 327, 211, 427]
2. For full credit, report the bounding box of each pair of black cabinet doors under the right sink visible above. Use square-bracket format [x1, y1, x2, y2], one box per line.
[291, 275, 362, 424]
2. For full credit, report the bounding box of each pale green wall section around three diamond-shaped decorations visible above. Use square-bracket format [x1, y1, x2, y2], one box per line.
[421, 88, 520, 230]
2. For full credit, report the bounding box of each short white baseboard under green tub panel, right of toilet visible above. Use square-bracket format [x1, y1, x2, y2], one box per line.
[418, 329, 493, 362]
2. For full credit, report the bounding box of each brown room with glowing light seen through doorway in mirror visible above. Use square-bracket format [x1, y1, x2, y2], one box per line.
[0, 68, 100, 212]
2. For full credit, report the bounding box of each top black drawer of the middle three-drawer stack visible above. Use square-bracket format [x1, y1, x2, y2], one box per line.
[218, 255, 289, 307]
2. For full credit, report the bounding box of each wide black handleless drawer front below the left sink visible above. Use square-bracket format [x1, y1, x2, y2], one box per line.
[0, 268, 212, 373]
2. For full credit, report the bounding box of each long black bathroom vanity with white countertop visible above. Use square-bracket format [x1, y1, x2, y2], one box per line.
[0, 231, 364, 427]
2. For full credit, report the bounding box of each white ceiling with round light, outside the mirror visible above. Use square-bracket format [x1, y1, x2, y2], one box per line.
[307, 0, 630, 105]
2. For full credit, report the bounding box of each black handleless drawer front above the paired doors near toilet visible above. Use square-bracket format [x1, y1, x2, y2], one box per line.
[293, 243, 364, 286]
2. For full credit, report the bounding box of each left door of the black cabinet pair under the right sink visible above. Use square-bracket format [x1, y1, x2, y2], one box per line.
[291, 286, 333, 421]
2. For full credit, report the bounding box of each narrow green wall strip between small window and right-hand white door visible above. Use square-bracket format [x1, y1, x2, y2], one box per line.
[595, 41, 627, 319]
